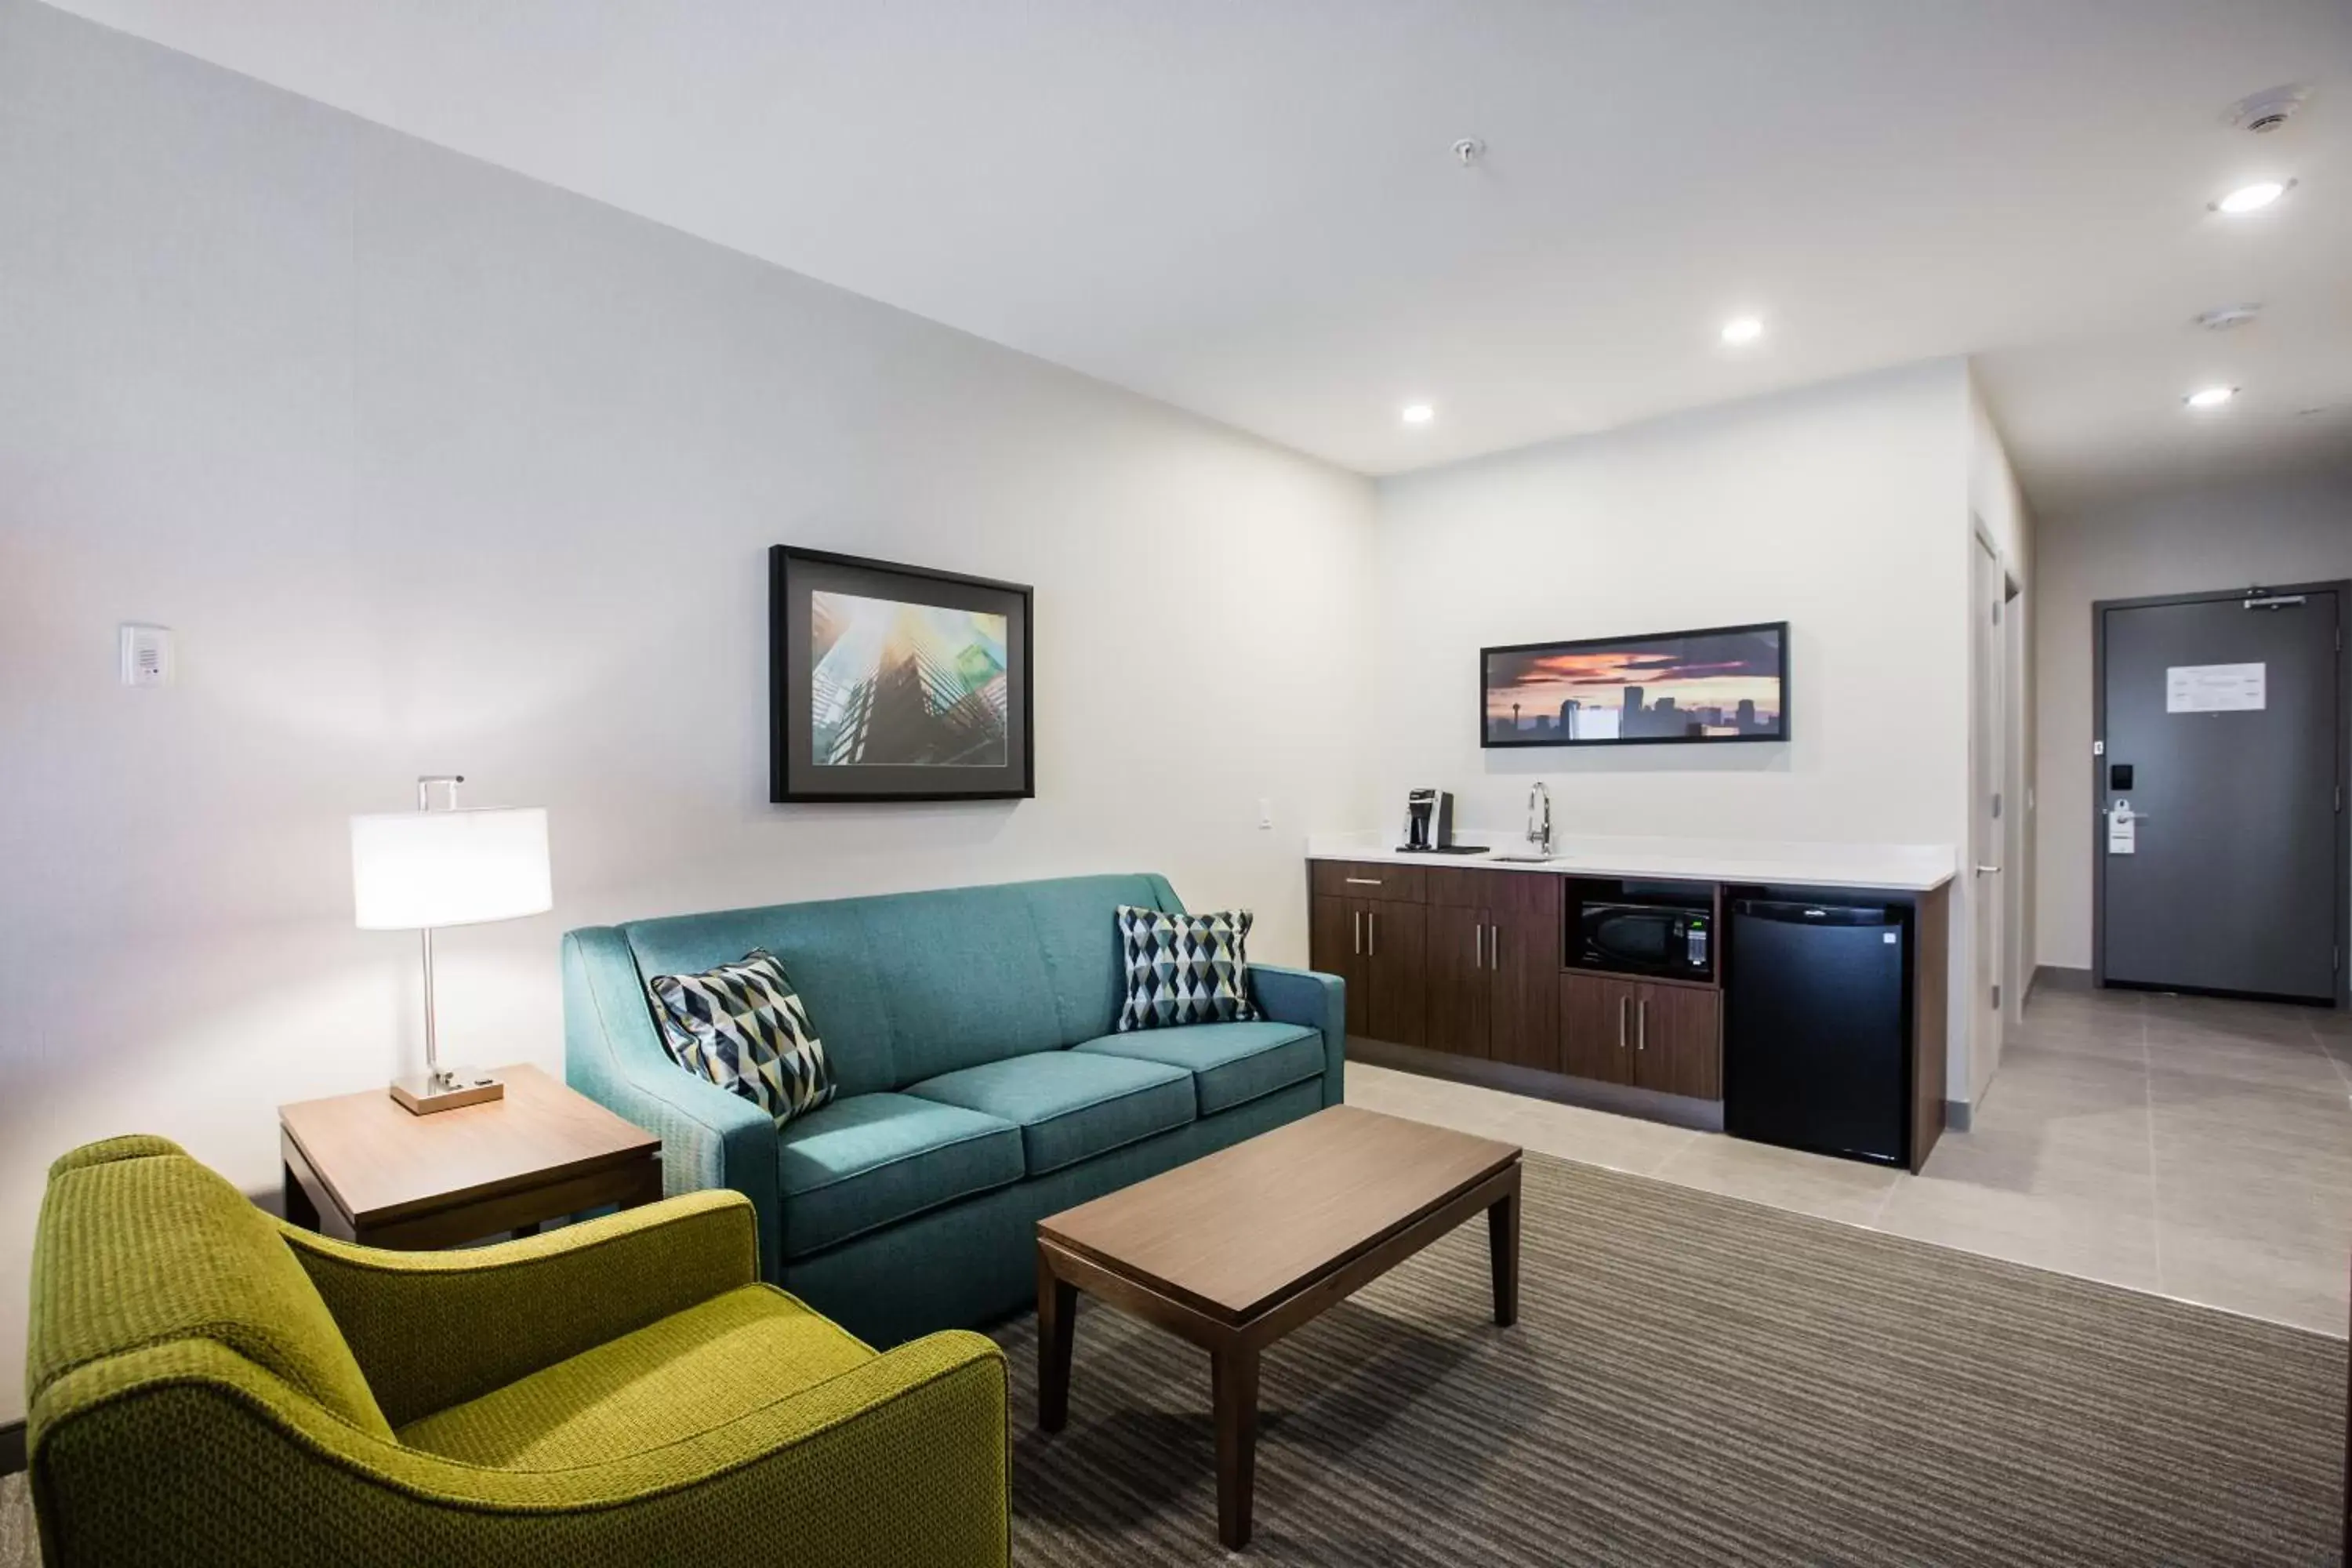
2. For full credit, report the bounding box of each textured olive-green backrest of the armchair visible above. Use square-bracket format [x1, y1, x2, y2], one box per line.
[26, 1135, 393, 1439]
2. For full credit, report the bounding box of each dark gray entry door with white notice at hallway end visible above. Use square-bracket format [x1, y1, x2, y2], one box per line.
[2091, 588, 2345, 1001]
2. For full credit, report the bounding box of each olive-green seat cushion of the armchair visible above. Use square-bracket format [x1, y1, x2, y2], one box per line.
[400, 1286, 875, 1469]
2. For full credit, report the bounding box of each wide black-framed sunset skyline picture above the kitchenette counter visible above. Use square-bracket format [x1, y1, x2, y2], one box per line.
[1479, 621, 1788, 748]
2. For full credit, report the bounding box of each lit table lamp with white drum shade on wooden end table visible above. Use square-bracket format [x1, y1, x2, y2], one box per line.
[350, 774, 555, 1116]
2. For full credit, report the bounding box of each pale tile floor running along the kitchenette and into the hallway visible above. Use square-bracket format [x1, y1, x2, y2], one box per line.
[1348, 987, 2352, 1338]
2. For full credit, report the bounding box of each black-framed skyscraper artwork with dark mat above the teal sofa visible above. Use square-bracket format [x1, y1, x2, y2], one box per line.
[767, 546, 1037, 801]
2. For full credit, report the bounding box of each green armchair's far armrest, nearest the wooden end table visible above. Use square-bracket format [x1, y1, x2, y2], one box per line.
[282, 1192, 760, 1427]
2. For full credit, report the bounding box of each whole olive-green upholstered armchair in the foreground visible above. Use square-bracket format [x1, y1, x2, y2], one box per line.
[26, 1138, 1009, 1568]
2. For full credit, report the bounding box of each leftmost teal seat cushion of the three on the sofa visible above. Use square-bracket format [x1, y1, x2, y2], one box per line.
[776, 1093, 1023, 1258]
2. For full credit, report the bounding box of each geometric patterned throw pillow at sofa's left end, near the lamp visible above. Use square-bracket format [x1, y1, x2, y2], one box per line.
[649, 947, 833, 1126]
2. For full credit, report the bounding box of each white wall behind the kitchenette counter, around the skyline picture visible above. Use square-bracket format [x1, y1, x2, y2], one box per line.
[1371, 360, 1973, 1098]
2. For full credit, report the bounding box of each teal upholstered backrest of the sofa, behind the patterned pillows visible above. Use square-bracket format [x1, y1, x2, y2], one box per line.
[621, 872, 1183, 1095]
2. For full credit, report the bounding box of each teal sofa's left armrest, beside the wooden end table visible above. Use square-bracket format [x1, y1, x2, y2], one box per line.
[564, 926, 783, 1279]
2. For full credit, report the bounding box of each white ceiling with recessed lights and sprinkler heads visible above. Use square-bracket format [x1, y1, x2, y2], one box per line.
[45, 0, 2352, 510]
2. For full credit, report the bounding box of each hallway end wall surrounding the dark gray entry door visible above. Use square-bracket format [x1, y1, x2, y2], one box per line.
[2034, 470, 2352, 968]
